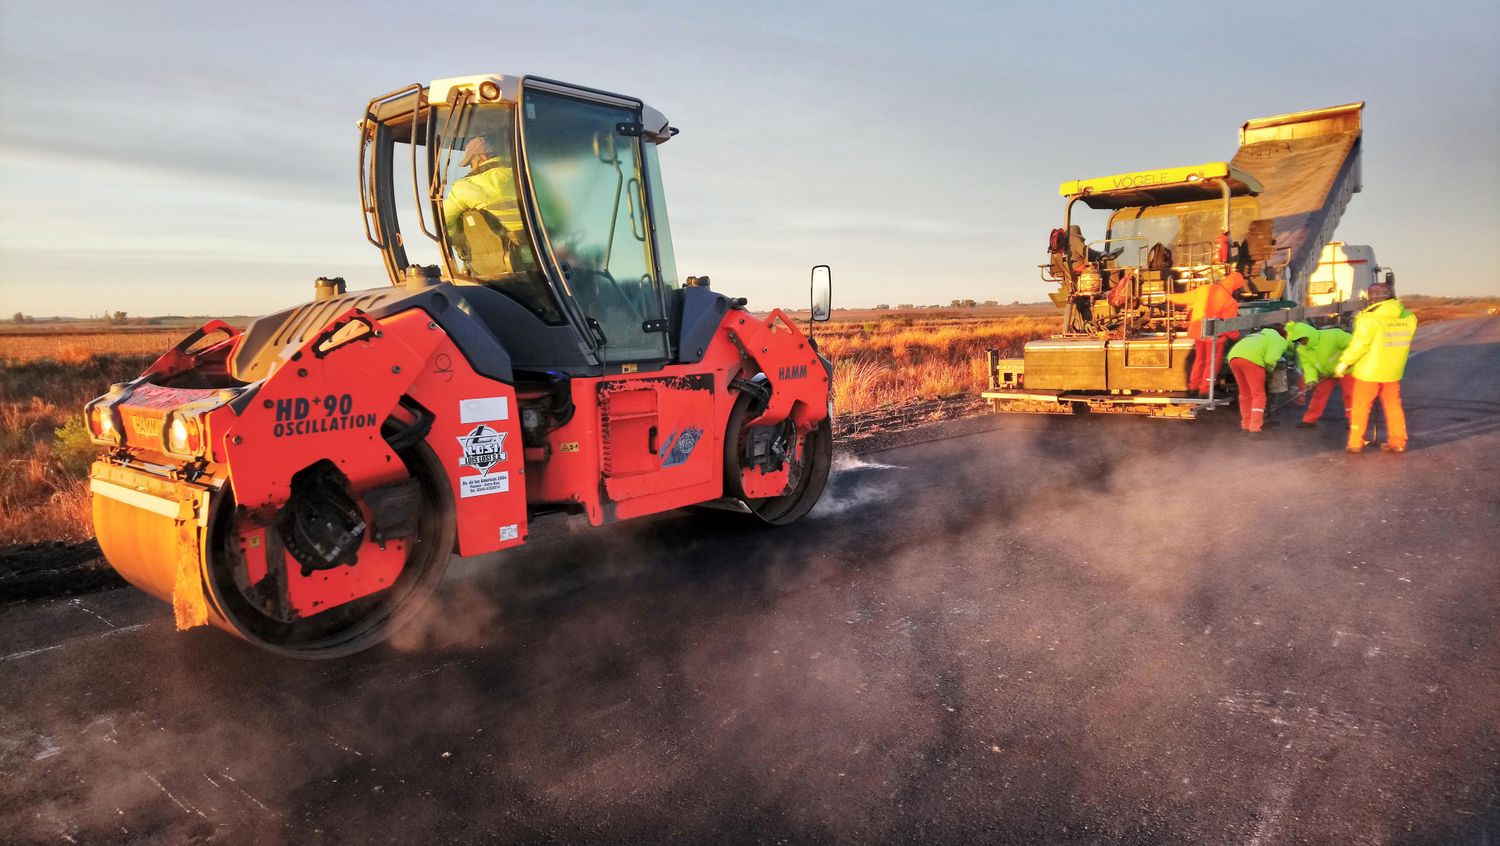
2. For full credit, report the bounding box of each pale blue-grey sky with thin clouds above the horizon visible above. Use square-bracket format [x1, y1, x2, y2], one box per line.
[0, 0, 1500, 317]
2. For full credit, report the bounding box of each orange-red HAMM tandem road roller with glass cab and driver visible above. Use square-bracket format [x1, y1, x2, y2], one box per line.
[86, 75, 833, 659]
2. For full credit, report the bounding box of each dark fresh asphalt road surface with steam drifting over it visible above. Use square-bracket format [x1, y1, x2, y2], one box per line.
[0, 318, 1500, 845]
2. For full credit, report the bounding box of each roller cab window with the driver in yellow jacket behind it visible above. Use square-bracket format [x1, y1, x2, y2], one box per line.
[431, 104, 563, 323]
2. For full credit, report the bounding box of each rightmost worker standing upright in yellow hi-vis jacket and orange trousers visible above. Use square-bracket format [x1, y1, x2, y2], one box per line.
[1334, 282, 1416, 453]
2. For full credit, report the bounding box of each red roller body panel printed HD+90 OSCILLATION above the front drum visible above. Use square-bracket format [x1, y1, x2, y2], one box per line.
[224, 309, 527, 564]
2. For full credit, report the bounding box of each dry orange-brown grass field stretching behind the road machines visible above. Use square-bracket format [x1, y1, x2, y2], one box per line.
[0, 297, 1500, 548]
